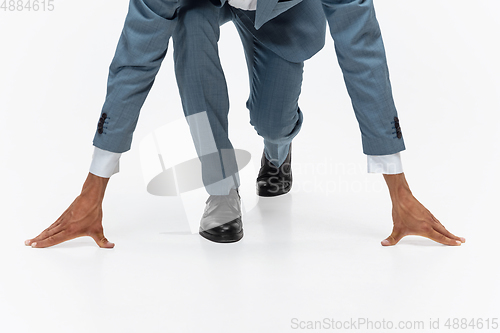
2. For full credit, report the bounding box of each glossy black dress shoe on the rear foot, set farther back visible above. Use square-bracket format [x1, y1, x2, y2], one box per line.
[257, 144, 292, 197]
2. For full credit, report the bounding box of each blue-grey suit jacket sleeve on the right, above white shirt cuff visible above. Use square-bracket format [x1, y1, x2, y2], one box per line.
[322, 0, 405, 155]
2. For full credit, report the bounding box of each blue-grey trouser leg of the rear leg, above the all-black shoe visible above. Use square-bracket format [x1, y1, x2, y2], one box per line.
[233, 9, 304, 167]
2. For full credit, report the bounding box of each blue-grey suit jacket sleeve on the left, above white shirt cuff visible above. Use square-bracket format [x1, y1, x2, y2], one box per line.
[94, 0, 179, 153]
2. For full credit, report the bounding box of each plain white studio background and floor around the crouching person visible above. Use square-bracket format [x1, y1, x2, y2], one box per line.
[0, 0, 500, 332]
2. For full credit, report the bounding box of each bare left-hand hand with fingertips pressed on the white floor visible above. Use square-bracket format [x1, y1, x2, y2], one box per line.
[24, 173, 115, 248]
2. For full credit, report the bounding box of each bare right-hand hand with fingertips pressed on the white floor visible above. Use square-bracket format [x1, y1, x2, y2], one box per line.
[382, 173, 465, 246]
